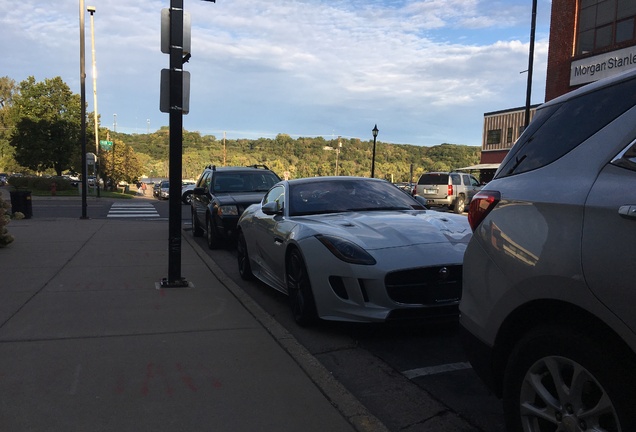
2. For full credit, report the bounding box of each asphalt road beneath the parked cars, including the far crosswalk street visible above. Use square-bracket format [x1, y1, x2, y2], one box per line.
[27, 197, 505, 432]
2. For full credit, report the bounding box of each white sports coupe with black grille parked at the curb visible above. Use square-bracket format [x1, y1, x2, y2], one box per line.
[237, 177, 471, 325]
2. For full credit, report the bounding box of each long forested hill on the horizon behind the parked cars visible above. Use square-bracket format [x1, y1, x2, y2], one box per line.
[111, 128, 481, 182]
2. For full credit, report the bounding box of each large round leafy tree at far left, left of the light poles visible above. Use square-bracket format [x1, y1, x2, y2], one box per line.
[9, 76, 81, 175]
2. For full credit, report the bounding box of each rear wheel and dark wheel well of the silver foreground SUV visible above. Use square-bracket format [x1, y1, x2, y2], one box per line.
[503, 326, 636, 432]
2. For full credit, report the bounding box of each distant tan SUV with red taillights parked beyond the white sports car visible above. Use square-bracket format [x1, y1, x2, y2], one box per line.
[415, 172, 481, 214]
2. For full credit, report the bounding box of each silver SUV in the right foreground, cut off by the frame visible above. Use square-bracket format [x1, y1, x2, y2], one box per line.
[460, 70, 636, 432]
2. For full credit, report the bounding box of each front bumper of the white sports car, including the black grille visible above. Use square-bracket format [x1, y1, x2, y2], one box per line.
[301, 240, 465, 322]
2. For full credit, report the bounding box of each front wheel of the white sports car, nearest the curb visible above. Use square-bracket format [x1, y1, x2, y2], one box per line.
[286, 249, 318, 327]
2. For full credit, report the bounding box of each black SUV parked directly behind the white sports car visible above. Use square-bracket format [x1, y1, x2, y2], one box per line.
[191, 165, 280, 249]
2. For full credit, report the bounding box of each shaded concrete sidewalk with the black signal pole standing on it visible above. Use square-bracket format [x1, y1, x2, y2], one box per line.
[0, 194, 386, 432]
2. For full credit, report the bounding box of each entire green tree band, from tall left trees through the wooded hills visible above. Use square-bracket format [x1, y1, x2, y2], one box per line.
[0, 77, 480, 182]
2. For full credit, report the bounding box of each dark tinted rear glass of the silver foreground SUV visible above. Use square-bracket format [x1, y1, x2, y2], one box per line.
[496, 79, 636, 178]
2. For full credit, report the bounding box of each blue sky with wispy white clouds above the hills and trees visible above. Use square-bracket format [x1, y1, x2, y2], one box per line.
[0, 0, 551, 146]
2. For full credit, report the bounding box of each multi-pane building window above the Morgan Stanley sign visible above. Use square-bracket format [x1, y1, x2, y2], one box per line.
[576, 0, 636, 54]
